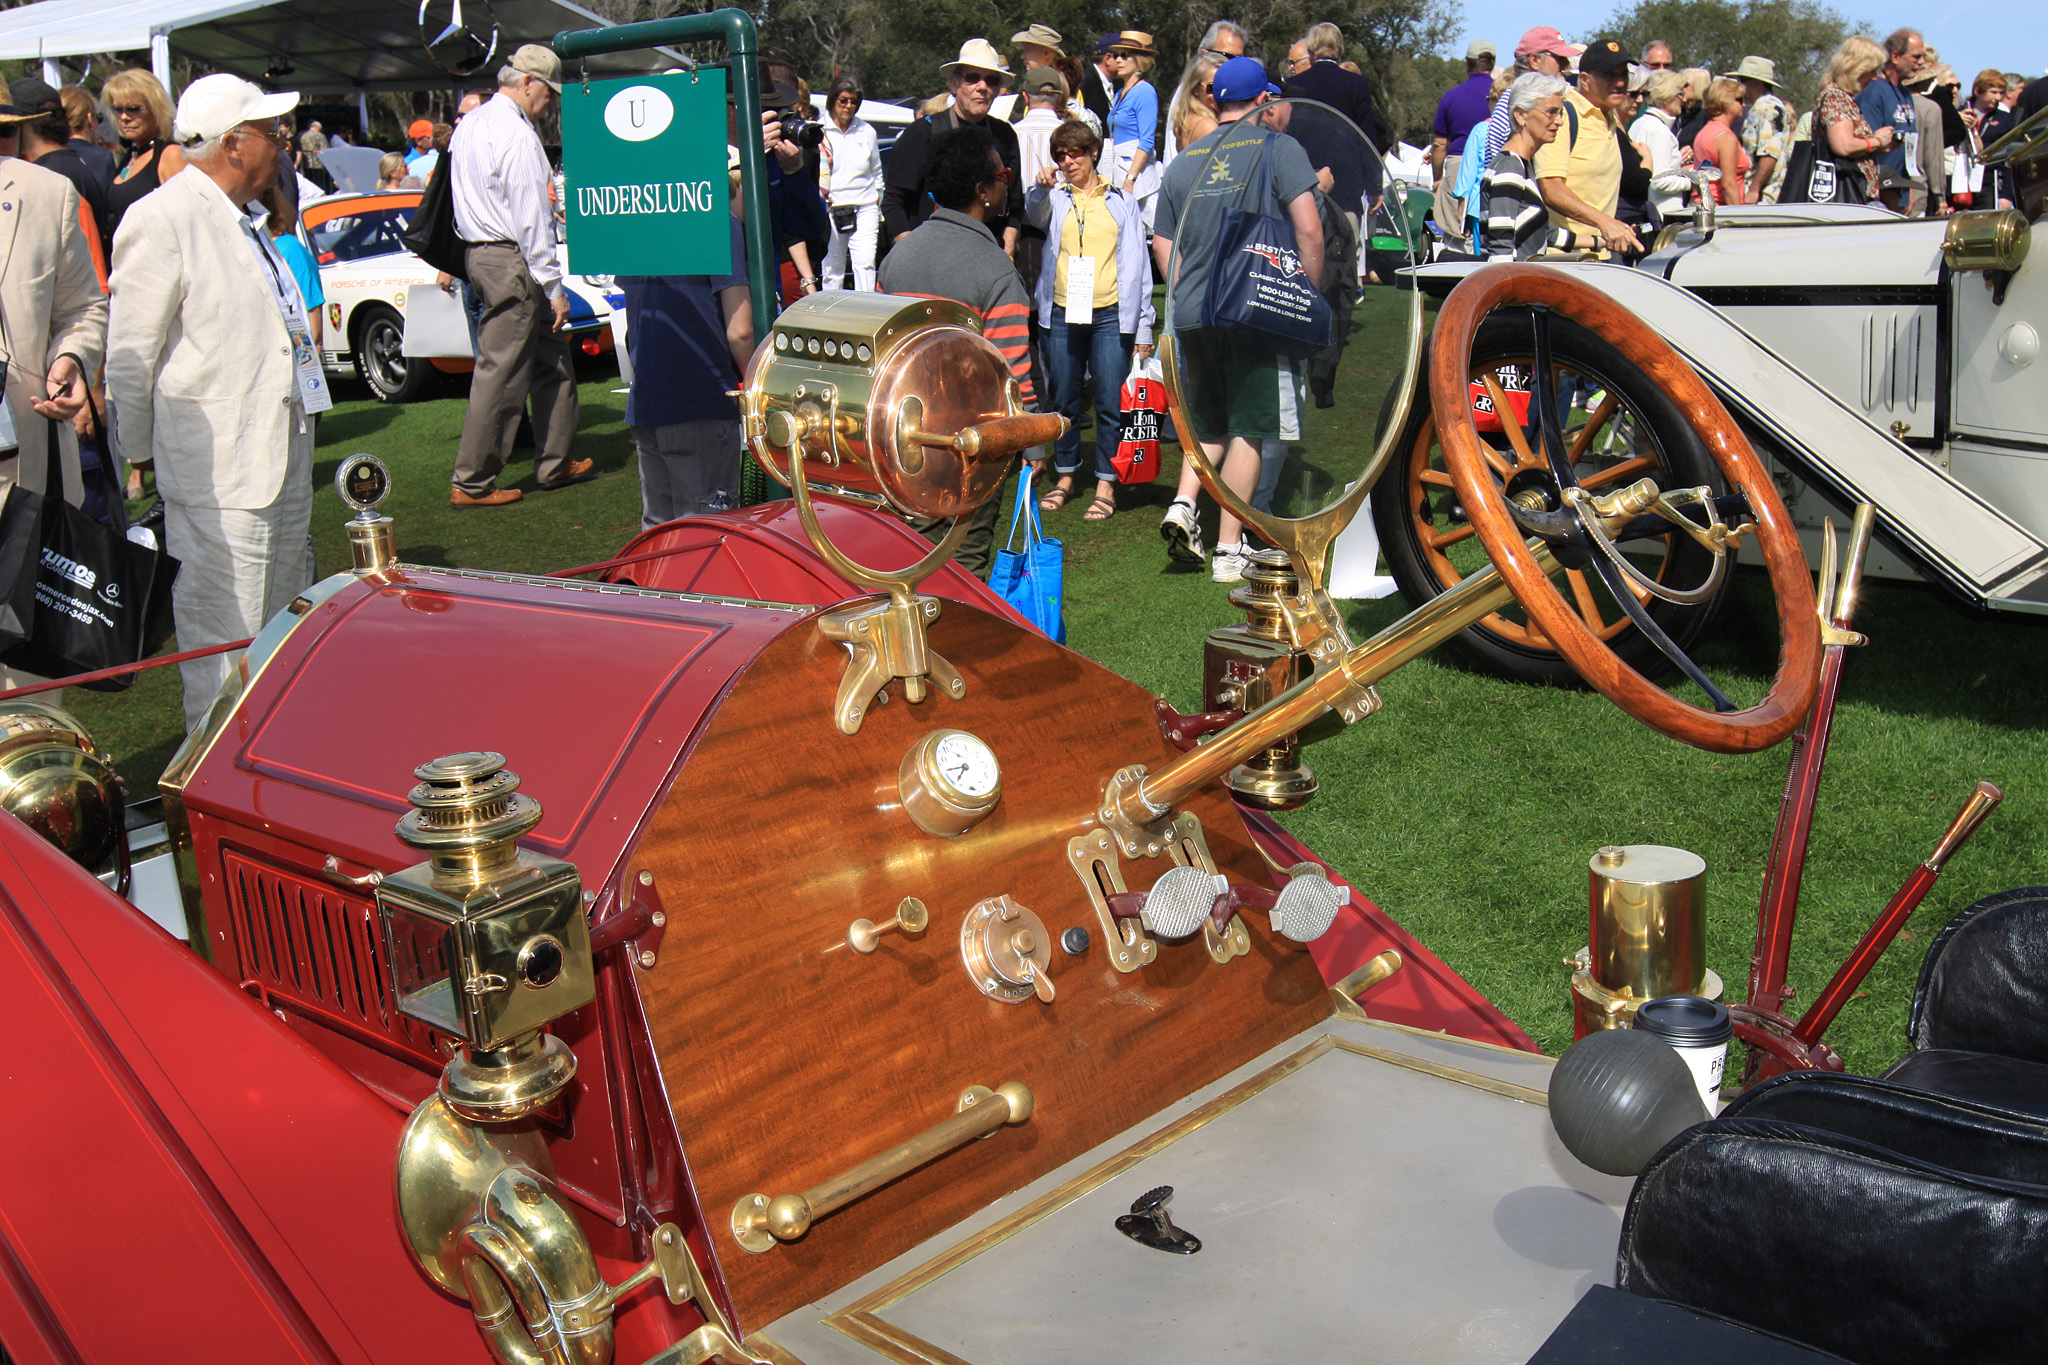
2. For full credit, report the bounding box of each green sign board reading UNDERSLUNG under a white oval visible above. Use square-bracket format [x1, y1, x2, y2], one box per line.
[561, 68, 733, 274]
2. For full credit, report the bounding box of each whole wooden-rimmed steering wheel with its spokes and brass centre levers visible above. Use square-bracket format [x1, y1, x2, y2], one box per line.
[1430, 266, 1821, 753]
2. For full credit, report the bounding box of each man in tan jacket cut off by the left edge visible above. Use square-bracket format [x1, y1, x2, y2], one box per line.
[0, 104, 106, 700]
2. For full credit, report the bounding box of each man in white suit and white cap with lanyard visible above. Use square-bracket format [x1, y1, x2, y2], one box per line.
[106, 74, 319, 729]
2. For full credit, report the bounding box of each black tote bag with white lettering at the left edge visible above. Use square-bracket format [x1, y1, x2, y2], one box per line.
[0, 424, 178, 692]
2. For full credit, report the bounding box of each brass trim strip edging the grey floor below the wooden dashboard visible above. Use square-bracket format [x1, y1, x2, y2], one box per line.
[815, 1023, 1550, 1365]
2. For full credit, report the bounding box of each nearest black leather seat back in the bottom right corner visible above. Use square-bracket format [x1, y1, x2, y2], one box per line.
[1616, 1072, 2048, 1365]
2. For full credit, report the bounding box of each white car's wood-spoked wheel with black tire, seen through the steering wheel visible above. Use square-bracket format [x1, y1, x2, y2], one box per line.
[1372, 311, 1726, 686]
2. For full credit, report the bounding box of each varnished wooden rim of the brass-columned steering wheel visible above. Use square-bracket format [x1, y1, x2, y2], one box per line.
[1430, 266, 1821, 753]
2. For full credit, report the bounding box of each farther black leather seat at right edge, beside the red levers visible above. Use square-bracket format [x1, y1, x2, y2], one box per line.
[1884, 886, 2048, 1117]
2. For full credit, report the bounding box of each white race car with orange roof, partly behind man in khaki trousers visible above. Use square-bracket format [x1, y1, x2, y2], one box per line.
[299, 190, 618, 403]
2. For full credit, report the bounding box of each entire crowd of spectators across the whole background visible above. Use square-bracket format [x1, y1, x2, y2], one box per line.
[0, 20, 2048, 724]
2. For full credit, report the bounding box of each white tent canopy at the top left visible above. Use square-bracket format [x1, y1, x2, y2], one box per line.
[0, 0, 666, 94]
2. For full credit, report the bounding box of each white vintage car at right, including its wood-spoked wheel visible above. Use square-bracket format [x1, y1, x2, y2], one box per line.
[1374, 127, 2048, 679]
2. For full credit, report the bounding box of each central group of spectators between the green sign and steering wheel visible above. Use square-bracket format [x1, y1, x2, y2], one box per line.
[704, 20, 1391, 583]
